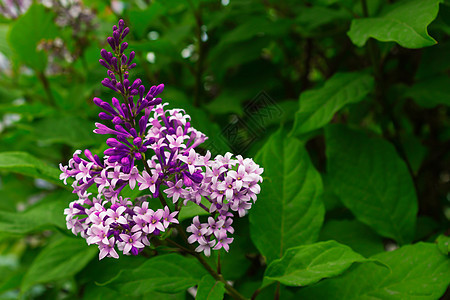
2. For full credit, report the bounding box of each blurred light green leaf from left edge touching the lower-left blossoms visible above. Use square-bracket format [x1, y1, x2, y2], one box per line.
[0, 191, 74, 234]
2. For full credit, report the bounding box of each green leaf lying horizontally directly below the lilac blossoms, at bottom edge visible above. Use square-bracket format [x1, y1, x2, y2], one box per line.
[108, 254, 206, 296]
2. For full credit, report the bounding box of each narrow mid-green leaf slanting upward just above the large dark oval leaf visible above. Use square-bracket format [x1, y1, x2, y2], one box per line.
[291, 72, 374, 136]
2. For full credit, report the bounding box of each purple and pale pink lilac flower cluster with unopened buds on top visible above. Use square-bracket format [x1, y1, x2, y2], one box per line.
[60, 20, 263, 259]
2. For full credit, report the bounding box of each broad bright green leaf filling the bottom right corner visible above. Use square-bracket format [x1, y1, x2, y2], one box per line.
[296, 243, 450, 300]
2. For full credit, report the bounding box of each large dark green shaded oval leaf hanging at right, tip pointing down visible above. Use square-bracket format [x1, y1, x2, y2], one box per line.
[325, 125, 417, 244]
